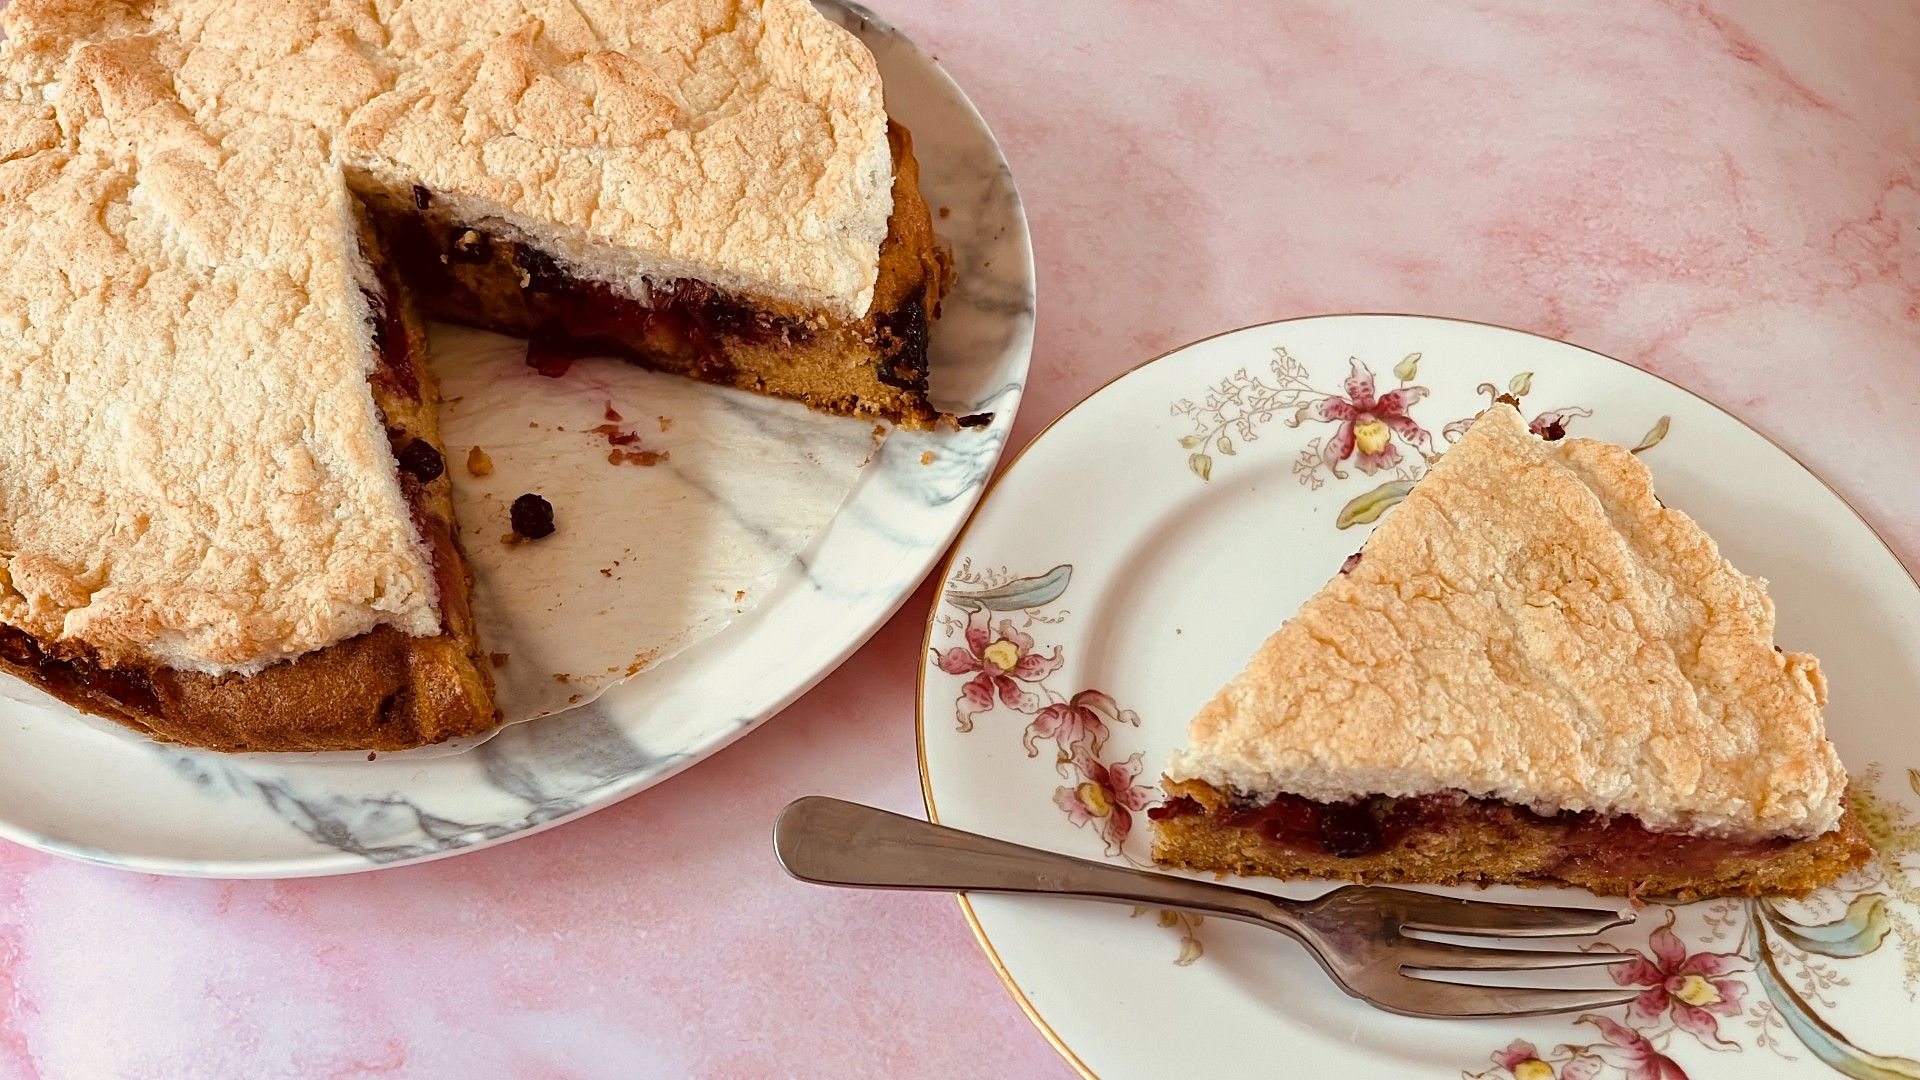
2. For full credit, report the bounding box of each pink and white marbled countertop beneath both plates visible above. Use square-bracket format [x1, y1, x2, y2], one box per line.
[0, 0, 1920, 1080]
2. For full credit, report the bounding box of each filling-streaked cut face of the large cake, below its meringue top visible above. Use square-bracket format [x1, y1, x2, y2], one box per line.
[349, 123, 958, 429]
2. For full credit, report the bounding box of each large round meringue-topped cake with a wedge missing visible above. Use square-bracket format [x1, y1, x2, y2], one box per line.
[0, 0, 947, 749]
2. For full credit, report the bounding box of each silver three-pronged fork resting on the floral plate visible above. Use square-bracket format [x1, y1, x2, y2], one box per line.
[774, 796, 1634, 1019]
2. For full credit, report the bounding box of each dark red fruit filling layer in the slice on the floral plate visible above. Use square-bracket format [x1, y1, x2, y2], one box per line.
[1146, 794, 1795, 876]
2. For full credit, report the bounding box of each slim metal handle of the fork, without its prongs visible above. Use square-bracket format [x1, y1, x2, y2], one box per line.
[774, 796, 1292, 928]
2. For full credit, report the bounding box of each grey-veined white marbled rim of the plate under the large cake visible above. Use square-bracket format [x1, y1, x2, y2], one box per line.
[0, 6, 1033, 876]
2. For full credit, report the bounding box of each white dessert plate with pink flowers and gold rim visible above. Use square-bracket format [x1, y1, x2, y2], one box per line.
[920, 315, 1920, 1080]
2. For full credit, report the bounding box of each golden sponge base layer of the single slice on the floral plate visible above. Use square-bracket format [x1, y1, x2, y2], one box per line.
[1154, 780, 1872, 903]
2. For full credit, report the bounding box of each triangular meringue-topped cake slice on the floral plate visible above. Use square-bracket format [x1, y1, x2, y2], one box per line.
[1152, 405, 1868, 899]
